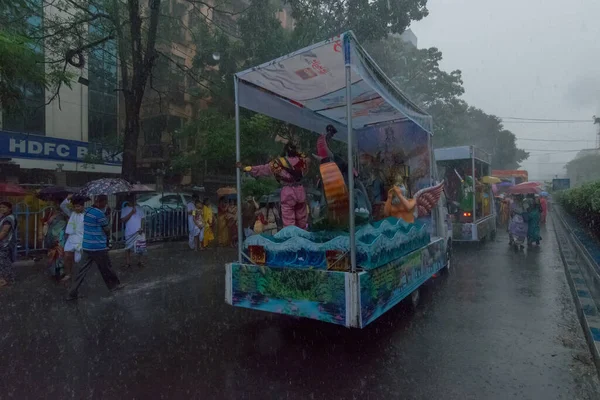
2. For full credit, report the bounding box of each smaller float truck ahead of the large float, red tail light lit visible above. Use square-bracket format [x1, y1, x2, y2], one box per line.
[435, 146, 501, 242]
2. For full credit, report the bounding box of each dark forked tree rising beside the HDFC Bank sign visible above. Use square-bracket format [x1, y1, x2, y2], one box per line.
[0, 0, 248, 181]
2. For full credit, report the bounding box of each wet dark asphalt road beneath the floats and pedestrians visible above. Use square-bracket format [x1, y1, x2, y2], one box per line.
[0, 216, 600, 400]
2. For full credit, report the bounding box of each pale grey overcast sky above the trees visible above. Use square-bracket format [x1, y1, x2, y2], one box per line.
[411, 0, 600, 179]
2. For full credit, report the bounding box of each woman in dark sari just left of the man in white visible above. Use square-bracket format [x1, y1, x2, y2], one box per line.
[42, 202, 68, 281]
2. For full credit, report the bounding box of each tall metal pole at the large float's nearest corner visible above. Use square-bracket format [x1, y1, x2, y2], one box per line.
[344, 37, 356, 272]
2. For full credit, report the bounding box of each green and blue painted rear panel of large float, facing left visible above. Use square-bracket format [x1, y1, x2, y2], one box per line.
[231, 264, 346, 325]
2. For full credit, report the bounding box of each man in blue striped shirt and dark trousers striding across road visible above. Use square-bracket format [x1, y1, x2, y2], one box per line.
[66, 195, 122, 300]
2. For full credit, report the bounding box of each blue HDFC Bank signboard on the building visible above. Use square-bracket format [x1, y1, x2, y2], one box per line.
[0, 131, 123, 165]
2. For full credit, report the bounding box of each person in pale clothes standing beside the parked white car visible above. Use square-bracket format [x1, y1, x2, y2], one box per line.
[121, 195, 146, 267]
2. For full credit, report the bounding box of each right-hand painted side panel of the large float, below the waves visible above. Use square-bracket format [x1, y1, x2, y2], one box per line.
[360, 239, 445, 327]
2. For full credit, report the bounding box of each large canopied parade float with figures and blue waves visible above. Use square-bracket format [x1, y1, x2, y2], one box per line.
[225, 32, 450, 328]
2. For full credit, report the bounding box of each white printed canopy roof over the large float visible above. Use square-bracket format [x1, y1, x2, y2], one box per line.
[236, 32, 432, 140]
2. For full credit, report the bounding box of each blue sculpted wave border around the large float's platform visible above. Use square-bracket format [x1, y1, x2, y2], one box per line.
[244, 217, 430, 269]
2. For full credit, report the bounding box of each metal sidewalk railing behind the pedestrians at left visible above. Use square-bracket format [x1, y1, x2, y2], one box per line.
[14, 203, 188, 255]
